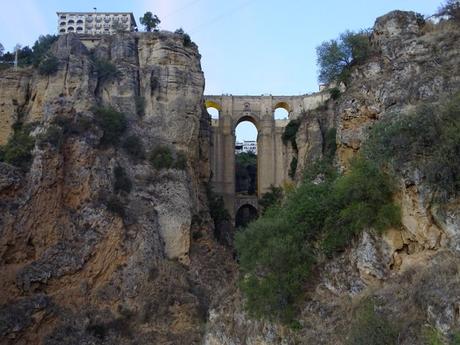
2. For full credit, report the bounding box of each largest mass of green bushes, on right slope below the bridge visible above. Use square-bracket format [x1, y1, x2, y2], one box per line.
[236, 159, 400, 322]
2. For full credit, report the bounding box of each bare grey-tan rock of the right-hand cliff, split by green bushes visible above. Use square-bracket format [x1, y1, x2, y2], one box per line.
[206, 11, 460, 345]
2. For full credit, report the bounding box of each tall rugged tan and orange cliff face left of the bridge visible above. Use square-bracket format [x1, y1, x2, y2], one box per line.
[0, 32, 233, 344]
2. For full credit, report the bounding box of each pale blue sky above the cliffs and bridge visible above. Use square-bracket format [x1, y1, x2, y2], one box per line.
[0, 0, 441, 139]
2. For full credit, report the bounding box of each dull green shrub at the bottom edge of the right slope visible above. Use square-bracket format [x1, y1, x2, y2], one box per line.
[347, 300, 399, 345]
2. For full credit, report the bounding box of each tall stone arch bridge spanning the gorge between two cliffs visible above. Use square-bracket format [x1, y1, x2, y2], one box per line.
[205, 92, 329, 219]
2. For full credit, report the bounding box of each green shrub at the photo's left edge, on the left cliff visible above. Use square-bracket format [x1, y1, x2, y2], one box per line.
[0, 123, 35, 171]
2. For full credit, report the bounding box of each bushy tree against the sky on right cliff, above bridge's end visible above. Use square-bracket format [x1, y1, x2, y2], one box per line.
[316, 31, 371, 84]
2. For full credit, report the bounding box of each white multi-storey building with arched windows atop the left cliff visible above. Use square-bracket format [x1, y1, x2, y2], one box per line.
[57, 12, 137, 35]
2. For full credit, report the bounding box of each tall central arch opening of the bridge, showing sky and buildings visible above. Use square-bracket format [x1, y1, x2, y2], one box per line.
[235, 117, 258, 195]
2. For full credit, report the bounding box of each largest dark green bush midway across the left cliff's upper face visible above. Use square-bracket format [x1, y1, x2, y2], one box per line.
[93, 107, 127, 146]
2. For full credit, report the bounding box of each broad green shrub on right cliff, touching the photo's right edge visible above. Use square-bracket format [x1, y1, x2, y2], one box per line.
[363, 93, 460, 202]
